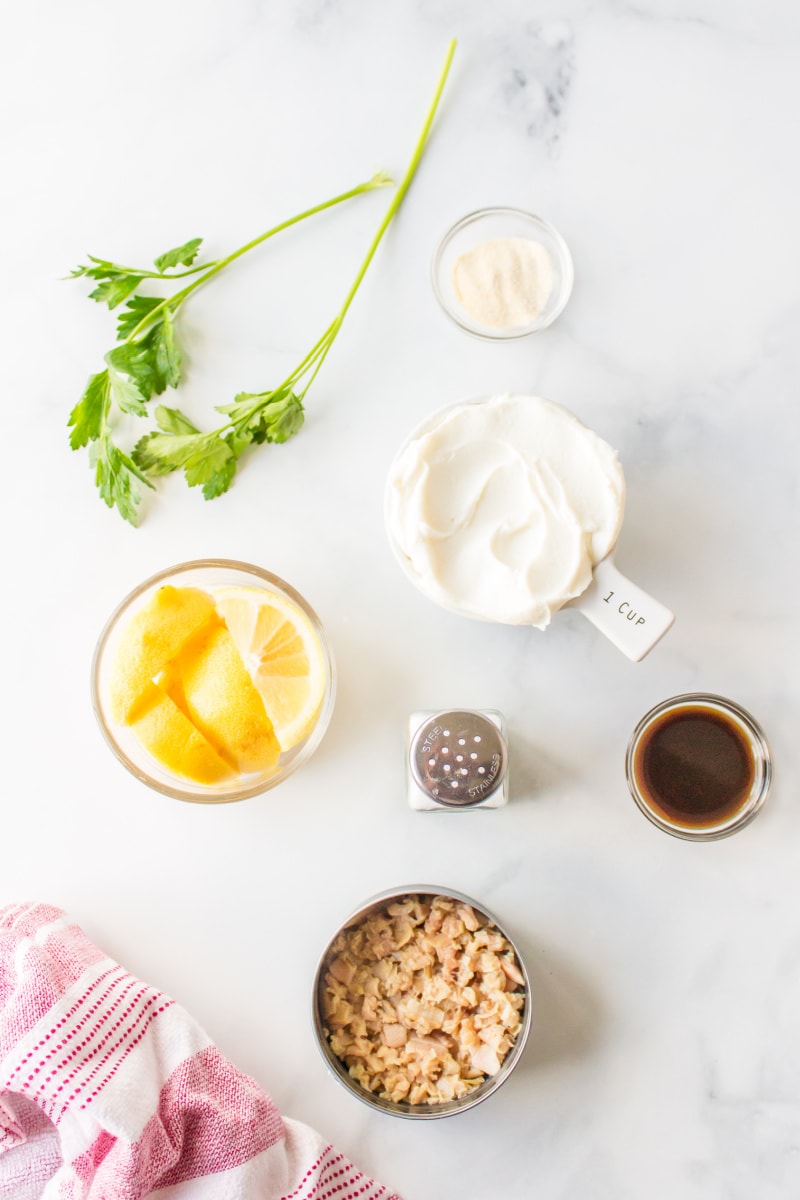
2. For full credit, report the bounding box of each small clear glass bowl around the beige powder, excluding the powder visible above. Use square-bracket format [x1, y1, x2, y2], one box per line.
[431, 208, 575, 342]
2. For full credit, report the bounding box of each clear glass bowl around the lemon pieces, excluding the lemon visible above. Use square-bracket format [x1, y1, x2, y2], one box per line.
[91, 558, 336, 804]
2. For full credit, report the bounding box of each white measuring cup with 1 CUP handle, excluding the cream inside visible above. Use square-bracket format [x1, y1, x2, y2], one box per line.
[385, 397, 674, 662]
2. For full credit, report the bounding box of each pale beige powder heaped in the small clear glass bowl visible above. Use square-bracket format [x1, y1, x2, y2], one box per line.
[452, 238, 553, 329]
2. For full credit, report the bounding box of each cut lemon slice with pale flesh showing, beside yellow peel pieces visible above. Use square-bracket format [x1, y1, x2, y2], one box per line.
[213, 588, 327, 751]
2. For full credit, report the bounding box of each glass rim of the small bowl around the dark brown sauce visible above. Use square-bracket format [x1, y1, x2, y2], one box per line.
[625, 691, 774, 841]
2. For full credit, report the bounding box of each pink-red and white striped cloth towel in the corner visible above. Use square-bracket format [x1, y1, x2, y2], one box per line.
[0, 904, 398, 1200]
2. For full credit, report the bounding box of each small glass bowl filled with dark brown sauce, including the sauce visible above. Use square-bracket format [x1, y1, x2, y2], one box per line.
[625, 692, 772, 841]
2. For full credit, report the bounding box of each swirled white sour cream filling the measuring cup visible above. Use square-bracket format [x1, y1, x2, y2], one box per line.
[385, 395, 625, 629]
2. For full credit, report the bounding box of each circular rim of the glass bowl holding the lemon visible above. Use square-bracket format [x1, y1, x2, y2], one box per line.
[91, 558, 336, 804]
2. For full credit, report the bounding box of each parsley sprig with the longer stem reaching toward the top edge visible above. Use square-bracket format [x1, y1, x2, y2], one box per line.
[132, 41, 456, 511]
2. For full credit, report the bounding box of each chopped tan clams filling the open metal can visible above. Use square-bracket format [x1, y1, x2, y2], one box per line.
[321, 896, 525, 1104]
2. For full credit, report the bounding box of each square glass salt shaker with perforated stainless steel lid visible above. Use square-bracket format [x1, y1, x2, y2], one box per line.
[407, 709, 509, 812]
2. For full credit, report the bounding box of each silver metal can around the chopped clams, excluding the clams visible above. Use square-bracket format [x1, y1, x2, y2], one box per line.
[312, 884, 533, 1121]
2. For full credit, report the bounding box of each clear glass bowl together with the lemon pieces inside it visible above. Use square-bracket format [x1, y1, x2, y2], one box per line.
[91, 558, 336, 804]
